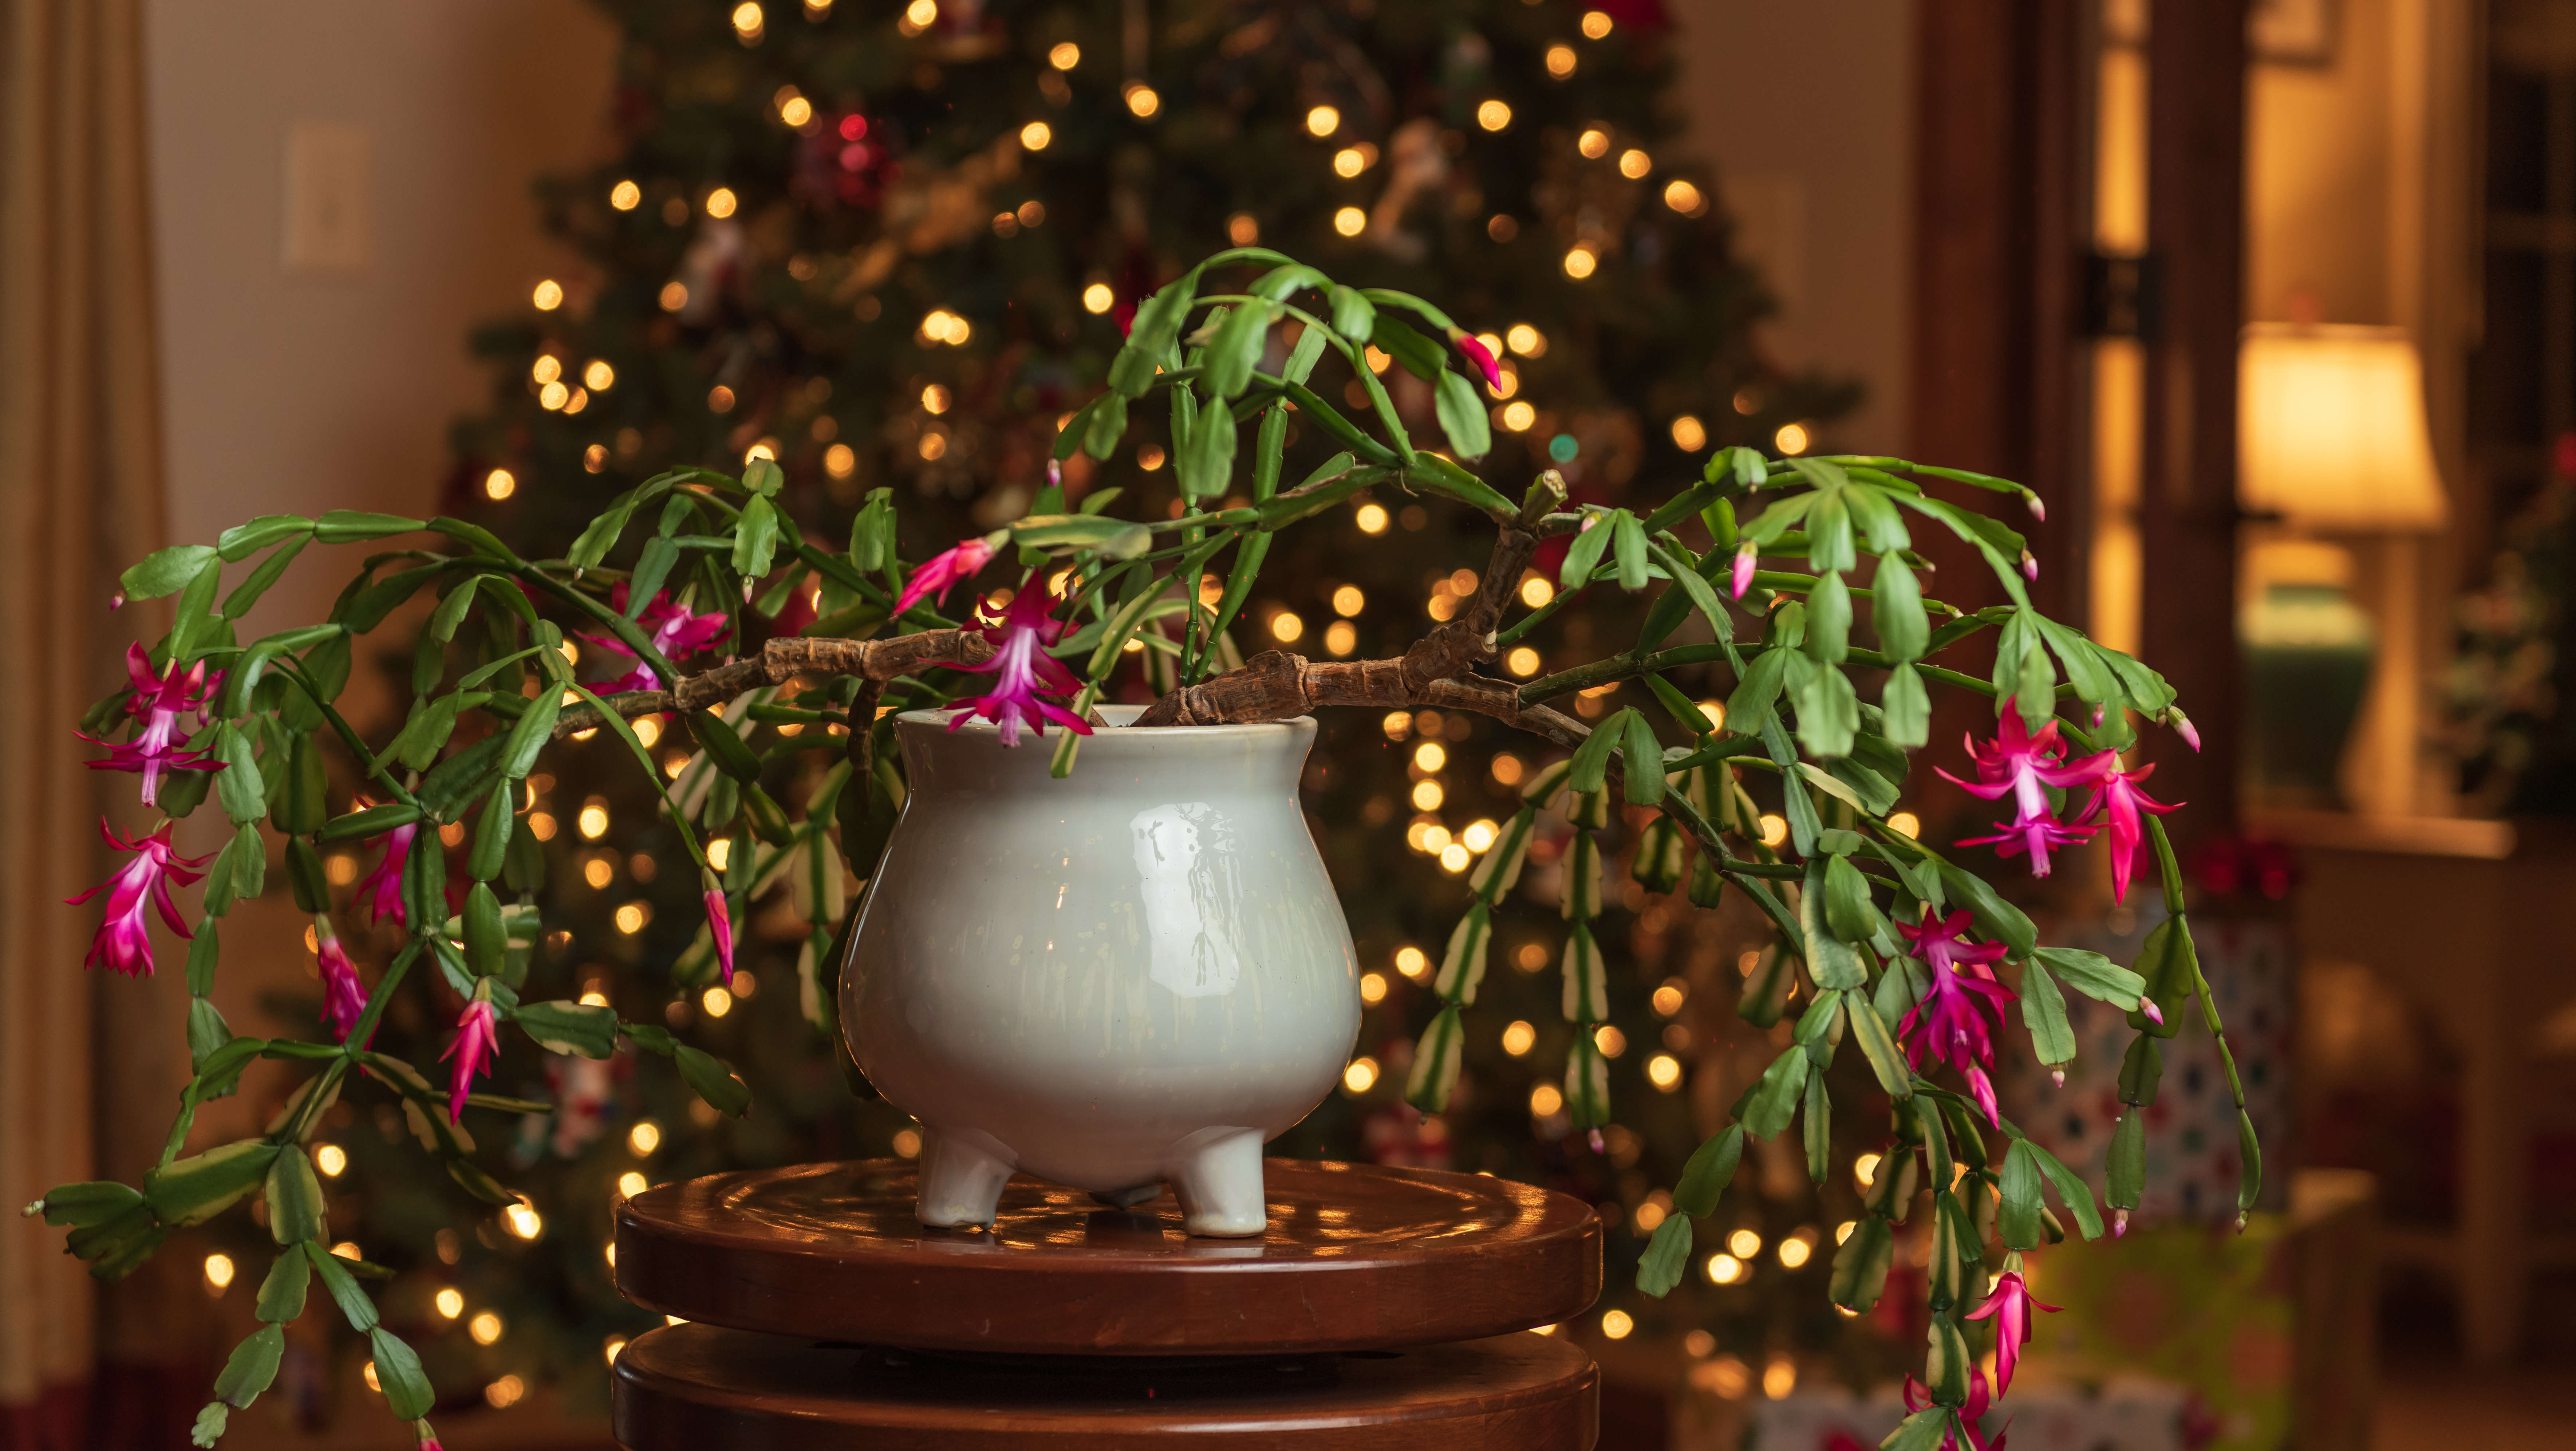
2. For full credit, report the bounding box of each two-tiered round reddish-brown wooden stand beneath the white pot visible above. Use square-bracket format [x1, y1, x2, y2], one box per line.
[613, 1160, 1602, 1451]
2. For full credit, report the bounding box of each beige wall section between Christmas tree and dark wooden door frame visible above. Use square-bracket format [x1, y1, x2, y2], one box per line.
[1672, 0, 1914, 451]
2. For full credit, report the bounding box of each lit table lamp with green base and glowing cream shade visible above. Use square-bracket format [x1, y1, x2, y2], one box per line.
[2236, 322, 2447, 807]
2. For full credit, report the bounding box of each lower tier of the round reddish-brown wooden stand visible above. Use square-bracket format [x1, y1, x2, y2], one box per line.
[611, 1325, 1600, 1451]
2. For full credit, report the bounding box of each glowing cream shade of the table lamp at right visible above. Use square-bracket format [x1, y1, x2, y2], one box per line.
[2236, 322, 2445, 531]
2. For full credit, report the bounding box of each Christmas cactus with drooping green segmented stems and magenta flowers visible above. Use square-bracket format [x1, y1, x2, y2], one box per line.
[31, 247, 2257, 1448]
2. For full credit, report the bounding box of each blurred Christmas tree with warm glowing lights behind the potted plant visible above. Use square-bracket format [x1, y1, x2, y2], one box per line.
[363, 0, 1865, 1402]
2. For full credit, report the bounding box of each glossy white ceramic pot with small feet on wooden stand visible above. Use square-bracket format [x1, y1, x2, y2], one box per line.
[840, 706, 1360, 1235]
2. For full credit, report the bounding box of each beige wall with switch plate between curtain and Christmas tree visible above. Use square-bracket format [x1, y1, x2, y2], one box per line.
[144, 0, 613, 636]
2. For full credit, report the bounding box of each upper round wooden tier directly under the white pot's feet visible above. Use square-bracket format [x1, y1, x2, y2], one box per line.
[616, 1160, 1602, 1356]
